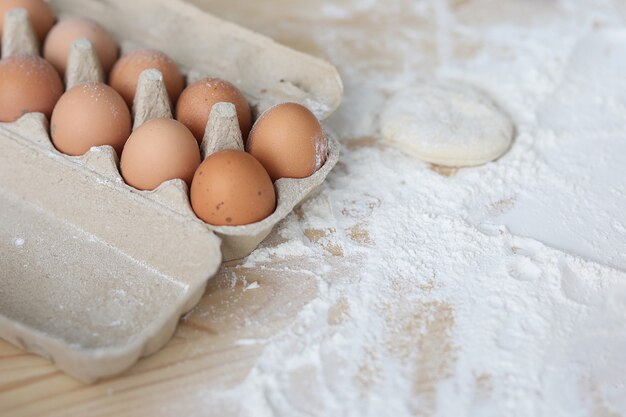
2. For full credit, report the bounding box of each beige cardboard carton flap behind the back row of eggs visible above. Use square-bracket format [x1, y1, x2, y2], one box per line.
[50, 0, 343, 120]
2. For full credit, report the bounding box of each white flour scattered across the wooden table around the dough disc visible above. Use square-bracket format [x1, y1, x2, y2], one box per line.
[176, 0, 626, 417]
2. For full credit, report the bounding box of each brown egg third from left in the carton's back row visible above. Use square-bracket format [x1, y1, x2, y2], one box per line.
[109, 49, 185, 106]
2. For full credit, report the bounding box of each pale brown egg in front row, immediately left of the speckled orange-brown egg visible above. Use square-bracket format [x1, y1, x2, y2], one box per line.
[120, 119, 200, 190]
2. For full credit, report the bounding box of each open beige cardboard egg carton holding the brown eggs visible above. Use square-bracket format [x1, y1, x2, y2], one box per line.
[0, 0, 342, 382]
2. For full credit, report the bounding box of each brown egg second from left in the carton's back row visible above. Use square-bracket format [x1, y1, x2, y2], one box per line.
[43, 19, 118, 75]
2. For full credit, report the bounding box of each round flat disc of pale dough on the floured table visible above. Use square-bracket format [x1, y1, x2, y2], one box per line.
[381, 83, 514, 167]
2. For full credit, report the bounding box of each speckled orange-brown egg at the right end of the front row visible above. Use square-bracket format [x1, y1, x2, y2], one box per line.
[191, 150, 276, 226]
